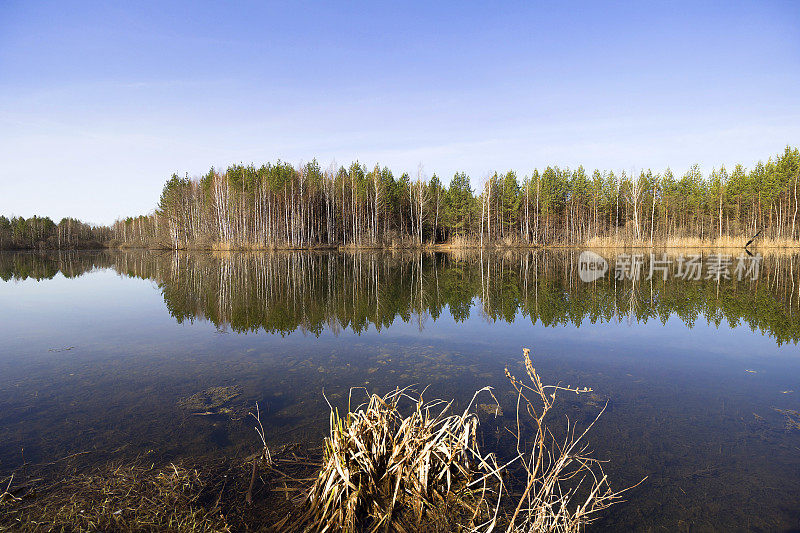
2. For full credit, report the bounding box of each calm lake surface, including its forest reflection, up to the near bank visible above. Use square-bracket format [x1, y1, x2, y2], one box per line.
[0, 251, 800, 531]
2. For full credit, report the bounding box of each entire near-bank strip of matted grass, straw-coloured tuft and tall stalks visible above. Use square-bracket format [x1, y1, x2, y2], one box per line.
[0, 349, 627, 533]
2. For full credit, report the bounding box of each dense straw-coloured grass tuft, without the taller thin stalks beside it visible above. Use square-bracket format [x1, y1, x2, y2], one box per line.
[303, 389, 497, 532]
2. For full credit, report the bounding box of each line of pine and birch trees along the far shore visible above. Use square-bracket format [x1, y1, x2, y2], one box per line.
[0, 146, 800, 249]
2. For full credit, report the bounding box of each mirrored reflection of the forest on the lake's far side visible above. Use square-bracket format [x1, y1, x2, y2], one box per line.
[0, 250, 800, 345]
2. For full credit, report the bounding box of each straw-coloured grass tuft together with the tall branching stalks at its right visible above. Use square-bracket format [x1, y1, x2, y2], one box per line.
[301, 349, 640, 533]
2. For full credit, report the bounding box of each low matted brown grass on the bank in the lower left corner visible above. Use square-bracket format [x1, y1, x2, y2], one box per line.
[0, 464, 230, 533]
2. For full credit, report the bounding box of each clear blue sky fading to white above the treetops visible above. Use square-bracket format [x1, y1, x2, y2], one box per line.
[0, 0, 800, 223]
